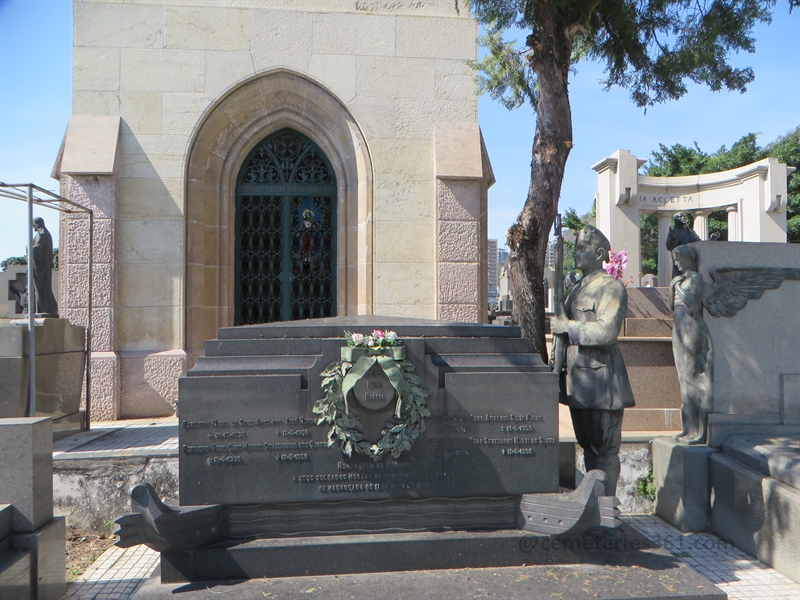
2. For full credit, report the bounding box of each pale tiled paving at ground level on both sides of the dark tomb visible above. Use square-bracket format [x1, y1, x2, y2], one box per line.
[53, 417, 800, 600]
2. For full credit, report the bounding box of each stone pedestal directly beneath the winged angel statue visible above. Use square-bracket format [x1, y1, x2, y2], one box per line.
[653, 438, 717, 533]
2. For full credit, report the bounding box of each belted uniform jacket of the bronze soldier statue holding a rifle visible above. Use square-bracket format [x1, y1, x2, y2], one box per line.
[561, 269, 635, 410]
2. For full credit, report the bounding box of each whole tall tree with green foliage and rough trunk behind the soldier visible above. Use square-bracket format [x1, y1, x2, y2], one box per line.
[462, 0, 800, 358]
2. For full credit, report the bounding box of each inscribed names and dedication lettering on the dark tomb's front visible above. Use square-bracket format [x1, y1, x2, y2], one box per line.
[181, 390, 556, 497]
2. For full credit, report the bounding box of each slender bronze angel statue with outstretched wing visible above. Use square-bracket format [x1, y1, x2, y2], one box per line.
[670, 246, 800, 444]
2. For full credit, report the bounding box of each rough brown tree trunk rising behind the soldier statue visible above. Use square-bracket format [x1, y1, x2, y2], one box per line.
[507, 5, 572, 363]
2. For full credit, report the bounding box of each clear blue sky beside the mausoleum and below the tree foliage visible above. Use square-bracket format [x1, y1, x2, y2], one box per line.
[0, 0, 800, 259]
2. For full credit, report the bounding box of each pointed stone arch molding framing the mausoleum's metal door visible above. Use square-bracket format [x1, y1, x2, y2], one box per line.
[185, 70, 373, 354]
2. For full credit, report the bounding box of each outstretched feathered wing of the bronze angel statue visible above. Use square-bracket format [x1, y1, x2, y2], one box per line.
[703, 267, 800, 317]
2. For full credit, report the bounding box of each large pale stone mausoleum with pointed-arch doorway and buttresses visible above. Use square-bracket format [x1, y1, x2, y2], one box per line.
[53, 0, 493, 420]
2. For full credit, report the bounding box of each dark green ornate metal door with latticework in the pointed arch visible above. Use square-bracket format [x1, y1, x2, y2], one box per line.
[234, 129, 336, 325]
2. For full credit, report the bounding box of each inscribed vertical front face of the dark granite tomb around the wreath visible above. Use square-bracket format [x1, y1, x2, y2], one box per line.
[179, 373, 558, 505]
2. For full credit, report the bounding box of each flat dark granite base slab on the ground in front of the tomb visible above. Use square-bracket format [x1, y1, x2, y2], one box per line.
[144, 525, 726, 600]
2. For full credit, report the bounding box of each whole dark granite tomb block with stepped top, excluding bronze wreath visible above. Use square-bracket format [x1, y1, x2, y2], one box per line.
[179, 316, 558, 505]
